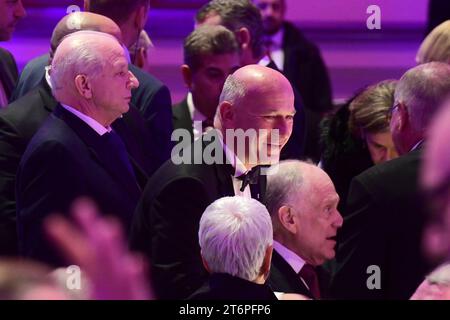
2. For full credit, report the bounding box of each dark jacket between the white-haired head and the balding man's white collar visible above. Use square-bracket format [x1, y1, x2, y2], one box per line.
[267, 250, 313, 299]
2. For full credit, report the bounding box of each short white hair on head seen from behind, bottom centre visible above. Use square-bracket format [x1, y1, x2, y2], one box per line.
[198, 196, 273, 281]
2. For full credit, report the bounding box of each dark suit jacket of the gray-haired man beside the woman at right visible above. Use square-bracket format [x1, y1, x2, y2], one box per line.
[331, 150, 428, 299]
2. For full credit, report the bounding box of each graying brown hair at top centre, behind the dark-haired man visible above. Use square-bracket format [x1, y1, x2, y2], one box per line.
[195, 0, 264, 58]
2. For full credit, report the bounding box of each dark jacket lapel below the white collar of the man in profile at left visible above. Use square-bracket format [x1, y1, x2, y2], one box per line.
[54, 105, 141, 199]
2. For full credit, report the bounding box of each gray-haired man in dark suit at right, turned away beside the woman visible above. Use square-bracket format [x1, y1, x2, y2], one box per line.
[331, 62, 450, 299]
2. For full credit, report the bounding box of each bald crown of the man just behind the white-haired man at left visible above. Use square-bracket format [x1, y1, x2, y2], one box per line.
[50, 12, 122, 59]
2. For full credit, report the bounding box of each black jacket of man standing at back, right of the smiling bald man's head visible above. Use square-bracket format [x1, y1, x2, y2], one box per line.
[283, 22, 332, 113]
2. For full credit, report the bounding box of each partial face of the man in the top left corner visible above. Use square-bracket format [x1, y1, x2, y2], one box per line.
[0, 0, 26, 41]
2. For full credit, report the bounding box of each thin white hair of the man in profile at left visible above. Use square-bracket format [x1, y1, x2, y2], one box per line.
[50, 30, 120, 96]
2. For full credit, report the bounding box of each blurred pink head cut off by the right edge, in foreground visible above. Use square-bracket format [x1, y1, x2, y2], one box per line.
[422, 101, 450, 262]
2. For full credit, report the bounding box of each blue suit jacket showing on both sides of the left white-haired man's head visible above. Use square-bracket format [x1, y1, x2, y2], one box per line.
[11, 54, 172, 162]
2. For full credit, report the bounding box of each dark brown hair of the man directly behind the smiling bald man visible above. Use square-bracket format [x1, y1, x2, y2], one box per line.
[184, 26, 239, 70]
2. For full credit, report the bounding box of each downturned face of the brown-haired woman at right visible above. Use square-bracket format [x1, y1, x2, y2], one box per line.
[364, 131, 398, 164]
